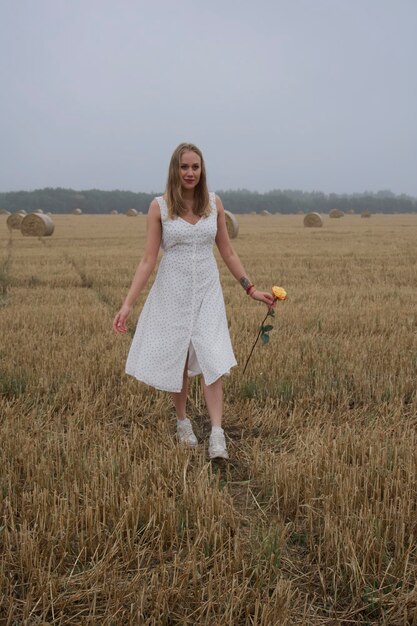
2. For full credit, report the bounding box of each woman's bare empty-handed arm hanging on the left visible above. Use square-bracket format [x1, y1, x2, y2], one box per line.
[113, 200, 162, 333]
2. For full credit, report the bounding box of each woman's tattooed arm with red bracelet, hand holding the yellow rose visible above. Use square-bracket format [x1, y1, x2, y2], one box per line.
[216, 196, 275, 307]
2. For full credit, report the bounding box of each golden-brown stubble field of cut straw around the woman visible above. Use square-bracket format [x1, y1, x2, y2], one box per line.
[0, 215, 417, 626]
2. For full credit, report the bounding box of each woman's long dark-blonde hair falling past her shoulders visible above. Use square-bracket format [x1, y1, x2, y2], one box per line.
[165, 143, 210, 219]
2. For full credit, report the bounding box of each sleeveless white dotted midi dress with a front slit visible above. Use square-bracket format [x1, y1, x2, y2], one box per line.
[126, 193, 236, 392]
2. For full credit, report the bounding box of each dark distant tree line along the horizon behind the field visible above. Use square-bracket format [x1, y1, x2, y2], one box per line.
[0, 187, 417, 214]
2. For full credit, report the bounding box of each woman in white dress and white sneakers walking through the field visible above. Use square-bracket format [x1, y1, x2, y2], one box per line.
[113, 143, 274, 459]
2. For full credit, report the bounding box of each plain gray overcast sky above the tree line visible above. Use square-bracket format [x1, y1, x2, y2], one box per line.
[0, 0, 417, 196]
